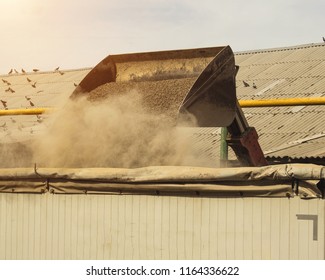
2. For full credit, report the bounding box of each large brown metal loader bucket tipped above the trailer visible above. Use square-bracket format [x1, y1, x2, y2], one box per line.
[72, 46, 236, 126]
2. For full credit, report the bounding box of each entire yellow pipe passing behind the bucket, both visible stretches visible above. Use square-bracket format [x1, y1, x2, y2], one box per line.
[0, 97, 325, 116]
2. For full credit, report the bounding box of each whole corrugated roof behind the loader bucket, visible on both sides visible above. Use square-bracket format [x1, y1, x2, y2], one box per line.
[0, 44, 325, 166]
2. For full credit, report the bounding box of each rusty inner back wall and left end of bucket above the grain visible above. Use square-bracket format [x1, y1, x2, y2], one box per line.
[72, 47, 223, 97]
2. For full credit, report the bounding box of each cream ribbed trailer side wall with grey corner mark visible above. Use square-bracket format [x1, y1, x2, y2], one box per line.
[0, 193, 325, 259]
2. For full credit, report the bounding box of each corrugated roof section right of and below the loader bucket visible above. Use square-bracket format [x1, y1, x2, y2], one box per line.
[189, 44, 325, 165]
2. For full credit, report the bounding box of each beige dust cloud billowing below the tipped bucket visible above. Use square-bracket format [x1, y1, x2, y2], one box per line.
[31, 91, 194, 168]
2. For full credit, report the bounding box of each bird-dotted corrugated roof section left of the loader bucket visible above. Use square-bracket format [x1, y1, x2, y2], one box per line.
[0, 69, 90, 143]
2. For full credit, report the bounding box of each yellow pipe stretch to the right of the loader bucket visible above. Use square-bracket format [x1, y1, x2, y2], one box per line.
[239, 97, 325, 108]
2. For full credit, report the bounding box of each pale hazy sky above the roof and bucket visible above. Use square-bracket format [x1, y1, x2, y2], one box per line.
[0, 0, 325, 74]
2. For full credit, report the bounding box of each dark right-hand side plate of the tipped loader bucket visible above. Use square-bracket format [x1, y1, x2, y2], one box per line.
[179, 46, 237, 127]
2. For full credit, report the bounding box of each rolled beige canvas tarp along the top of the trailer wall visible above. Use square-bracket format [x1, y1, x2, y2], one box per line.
[0, 164, 325, 198]
